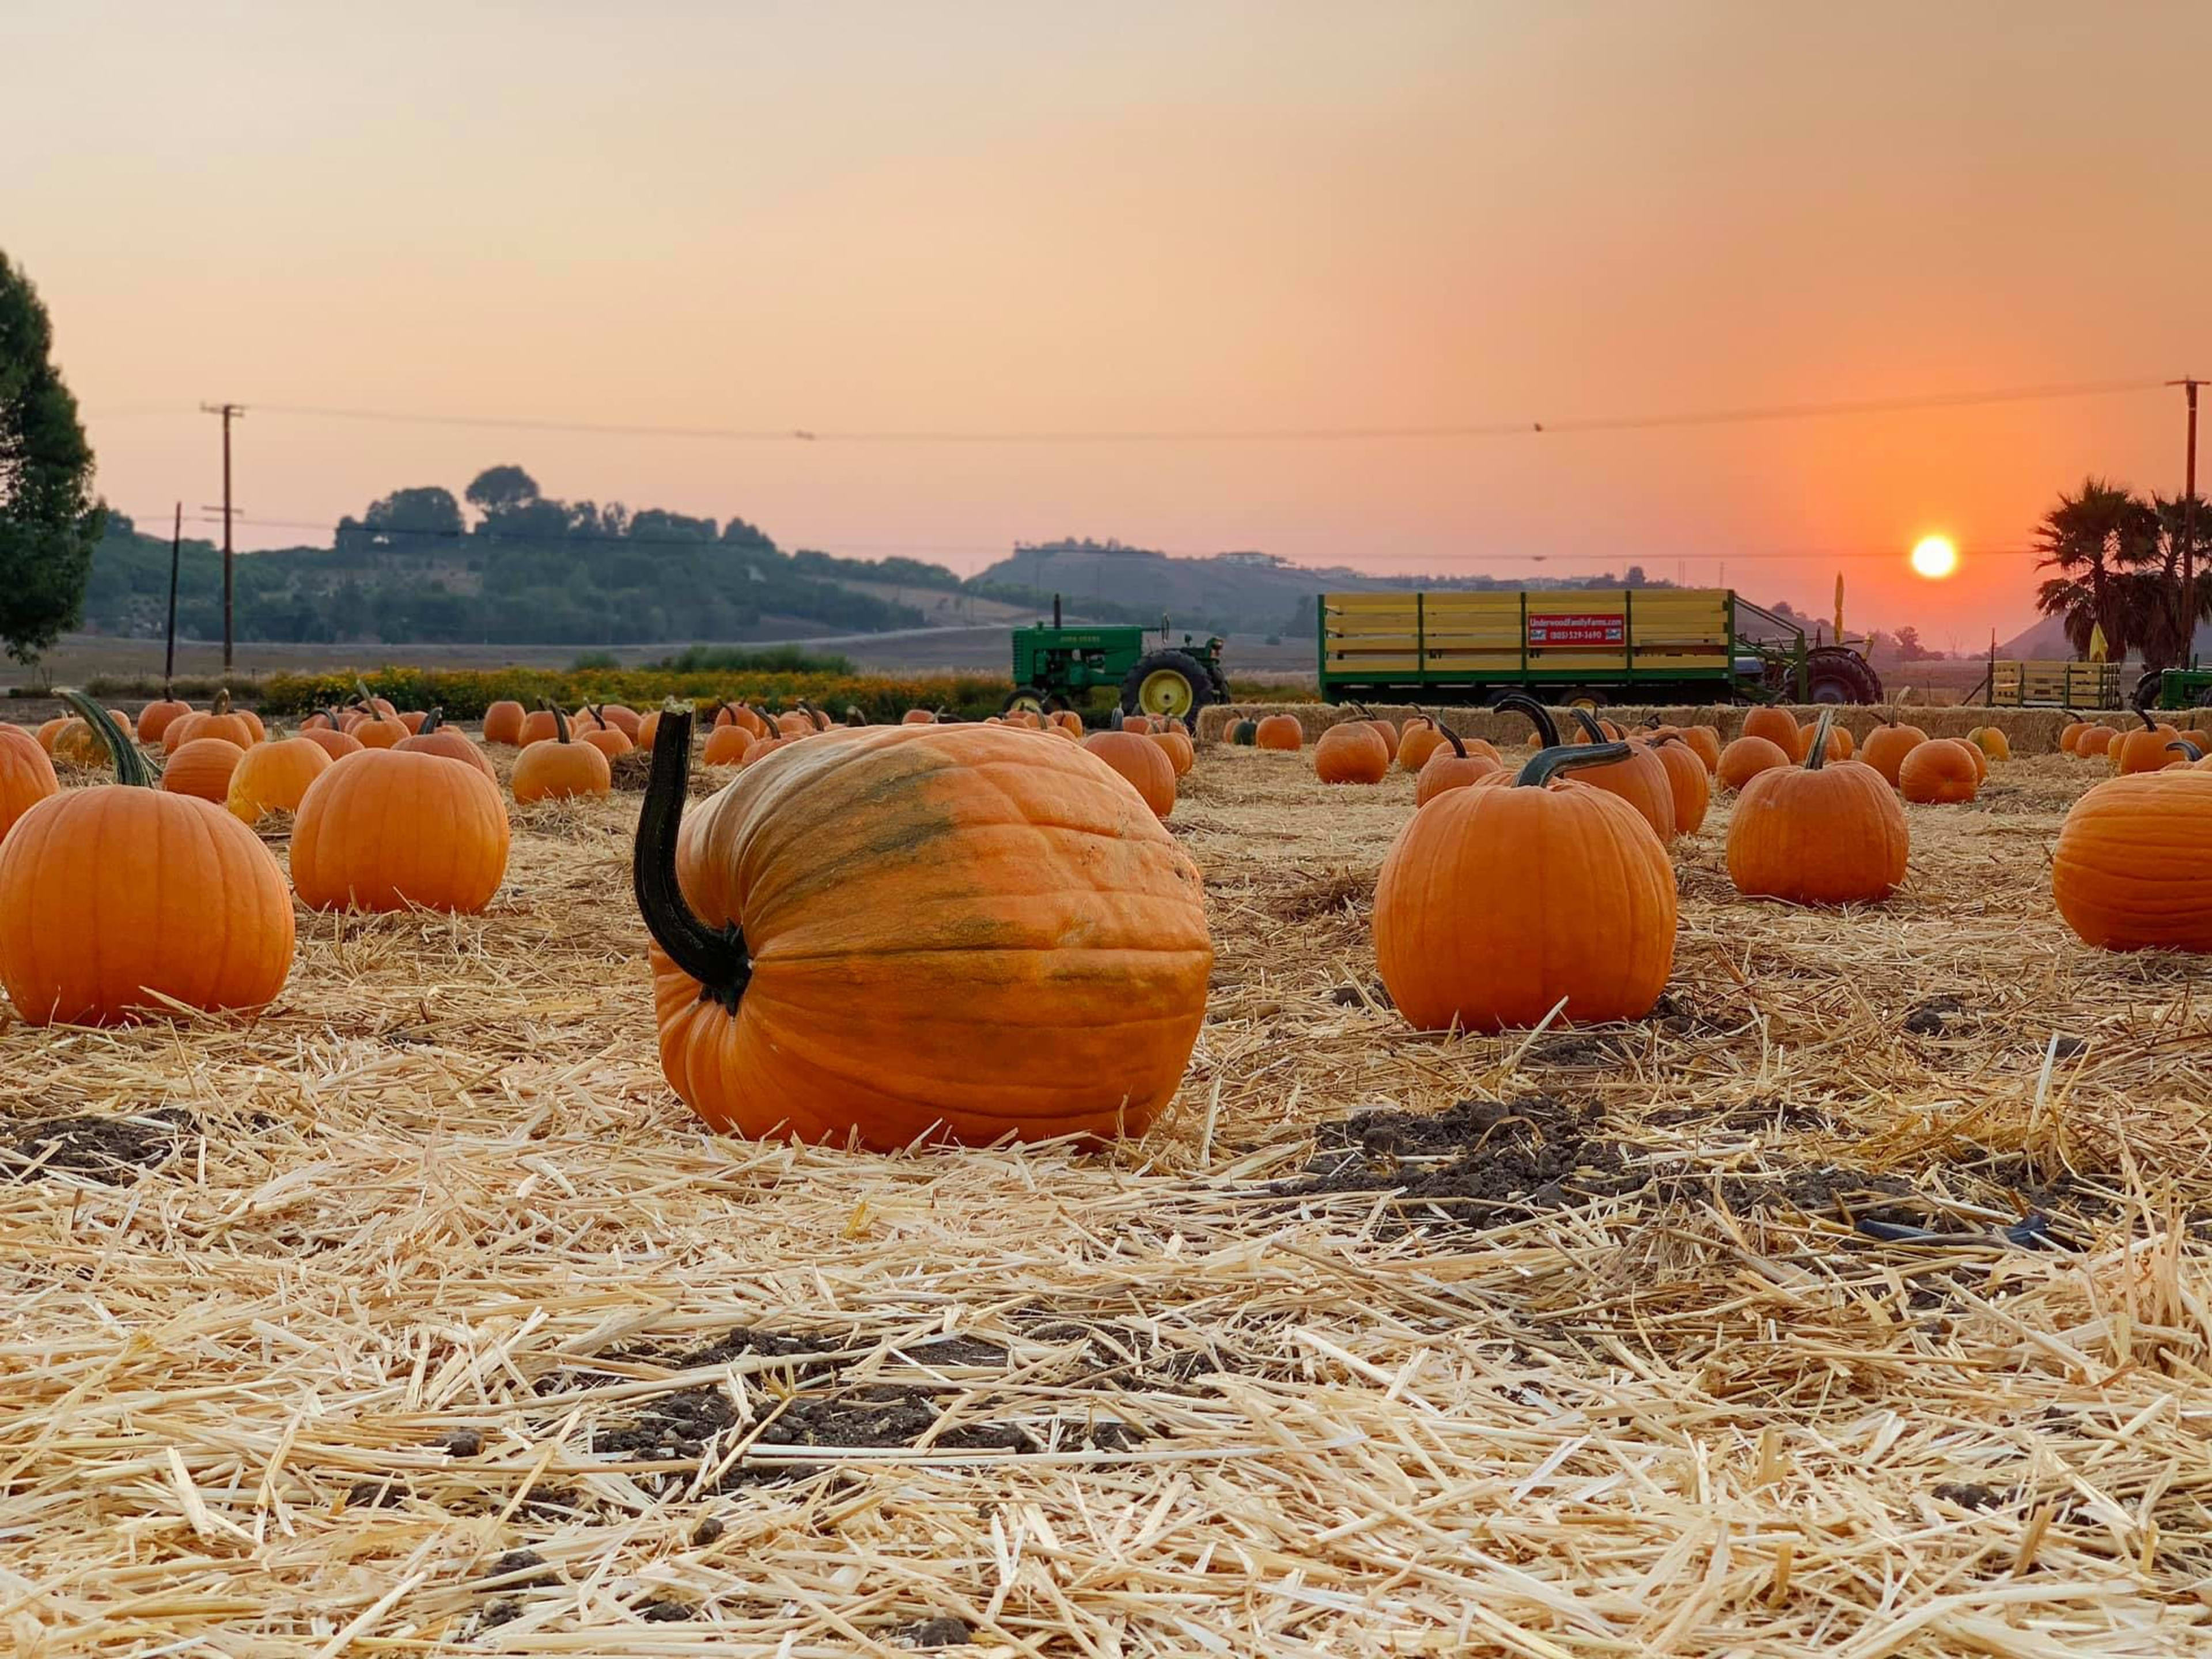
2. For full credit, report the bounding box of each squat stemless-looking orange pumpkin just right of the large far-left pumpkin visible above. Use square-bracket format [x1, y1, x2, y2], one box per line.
[292, 748, 506, 911]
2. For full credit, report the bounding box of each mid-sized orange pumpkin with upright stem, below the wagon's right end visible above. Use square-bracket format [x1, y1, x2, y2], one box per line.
[1728, 714, 1911, 905]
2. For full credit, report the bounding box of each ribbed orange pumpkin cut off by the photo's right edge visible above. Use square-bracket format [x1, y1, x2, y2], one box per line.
[2051, 770, 2212, 953]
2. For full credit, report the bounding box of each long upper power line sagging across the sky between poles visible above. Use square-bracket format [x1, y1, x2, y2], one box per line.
[147, 378, 2168, 445]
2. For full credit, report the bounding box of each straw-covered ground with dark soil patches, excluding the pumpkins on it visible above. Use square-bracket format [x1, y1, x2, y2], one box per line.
[0, 721, 2212, 1659]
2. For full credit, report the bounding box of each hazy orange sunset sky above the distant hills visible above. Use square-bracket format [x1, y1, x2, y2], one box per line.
[0, 0, 2212, 648]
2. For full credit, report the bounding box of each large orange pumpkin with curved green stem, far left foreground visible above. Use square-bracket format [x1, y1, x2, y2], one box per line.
[0, 692, 292, 1024]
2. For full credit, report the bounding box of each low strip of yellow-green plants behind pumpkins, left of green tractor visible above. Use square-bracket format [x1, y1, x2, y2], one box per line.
[261, 668, 1013, 721]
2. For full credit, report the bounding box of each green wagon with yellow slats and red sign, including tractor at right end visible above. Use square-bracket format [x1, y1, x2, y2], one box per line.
[1319, 588, 1883, 703]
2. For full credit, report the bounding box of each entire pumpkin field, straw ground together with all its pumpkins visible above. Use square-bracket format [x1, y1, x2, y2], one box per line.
[0, 685, 2212, 1659]
